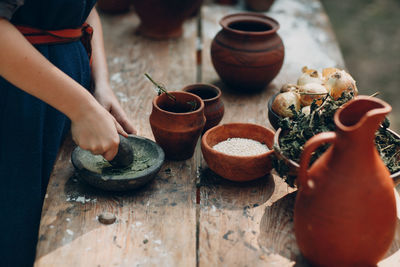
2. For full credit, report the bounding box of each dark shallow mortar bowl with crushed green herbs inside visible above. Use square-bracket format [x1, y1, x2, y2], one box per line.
[71, 135, 165, 191]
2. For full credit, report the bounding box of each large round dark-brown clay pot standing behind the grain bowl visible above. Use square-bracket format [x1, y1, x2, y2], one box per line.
[211, 13, 285, 90]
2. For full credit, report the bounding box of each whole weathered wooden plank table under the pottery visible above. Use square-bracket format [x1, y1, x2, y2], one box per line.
[35, 0, 400, 266]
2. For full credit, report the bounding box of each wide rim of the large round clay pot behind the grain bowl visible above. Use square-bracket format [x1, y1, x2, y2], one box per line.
[219, 12, 280, 36]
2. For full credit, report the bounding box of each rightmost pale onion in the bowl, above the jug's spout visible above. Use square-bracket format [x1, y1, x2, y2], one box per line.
[325, 70, 358, 99]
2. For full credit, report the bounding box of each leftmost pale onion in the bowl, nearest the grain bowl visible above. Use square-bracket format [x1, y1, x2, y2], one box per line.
[271, 92, 300, 118]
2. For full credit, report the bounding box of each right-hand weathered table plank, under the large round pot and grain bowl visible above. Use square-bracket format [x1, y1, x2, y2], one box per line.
[198, 0, 400, 266]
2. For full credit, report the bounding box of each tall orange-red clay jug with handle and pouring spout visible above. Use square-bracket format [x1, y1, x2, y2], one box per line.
[294, 96, 397, 266]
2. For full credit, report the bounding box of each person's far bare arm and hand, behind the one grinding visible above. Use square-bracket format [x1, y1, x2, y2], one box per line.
[86, 8, 136, 133]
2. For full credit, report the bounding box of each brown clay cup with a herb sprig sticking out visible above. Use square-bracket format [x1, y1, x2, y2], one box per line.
[150, 92, 206, 160]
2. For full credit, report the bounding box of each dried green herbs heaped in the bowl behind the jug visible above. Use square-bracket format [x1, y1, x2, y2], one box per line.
[273, 92, 400, 187]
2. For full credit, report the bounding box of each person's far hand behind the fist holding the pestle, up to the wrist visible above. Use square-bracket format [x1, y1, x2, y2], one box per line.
[94, 82, 136, 134]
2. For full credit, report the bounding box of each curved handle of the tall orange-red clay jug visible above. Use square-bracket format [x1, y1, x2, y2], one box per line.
[298, 132, 336, 188]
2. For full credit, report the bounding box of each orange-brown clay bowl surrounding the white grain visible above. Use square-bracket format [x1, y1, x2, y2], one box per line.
[201, 123, 274, 182]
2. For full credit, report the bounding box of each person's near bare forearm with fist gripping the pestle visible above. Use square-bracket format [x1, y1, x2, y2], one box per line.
[0, 18, 126, 160]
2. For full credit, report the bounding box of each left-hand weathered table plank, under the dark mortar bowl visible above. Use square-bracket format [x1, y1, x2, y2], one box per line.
[35, 10, 196, 266]
